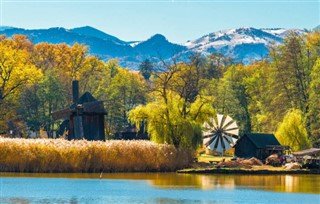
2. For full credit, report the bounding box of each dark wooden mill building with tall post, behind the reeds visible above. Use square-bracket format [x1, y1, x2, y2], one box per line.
[52, 81, 107, 140]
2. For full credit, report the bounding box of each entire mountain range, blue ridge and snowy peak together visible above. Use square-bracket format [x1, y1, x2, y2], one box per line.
[0, 26, 306, 69]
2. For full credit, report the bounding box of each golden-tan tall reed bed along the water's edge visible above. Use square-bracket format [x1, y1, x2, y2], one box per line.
[0, 137, 192, 172]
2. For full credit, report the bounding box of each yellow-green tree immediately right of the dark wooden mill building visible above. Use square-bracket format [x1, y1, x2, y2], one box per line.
[97, 66, 146, 136]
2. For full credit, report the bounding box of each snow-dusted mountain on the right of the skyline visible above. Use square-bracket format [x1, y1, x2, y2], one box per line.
[184, 27, 305, 63]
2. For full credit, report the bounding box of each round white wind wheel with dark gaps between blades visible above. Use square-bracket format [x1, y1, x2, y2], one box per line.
[203, 114, 239, 153]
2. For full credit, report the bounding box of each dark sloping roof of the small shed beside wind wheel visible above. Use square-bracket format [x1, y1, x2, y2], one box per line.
[239, 133, 280, 148]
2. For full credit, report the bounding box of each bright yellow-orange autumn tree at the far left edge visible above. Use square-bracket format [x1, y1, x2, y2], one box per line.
[0, 36, 42, 132]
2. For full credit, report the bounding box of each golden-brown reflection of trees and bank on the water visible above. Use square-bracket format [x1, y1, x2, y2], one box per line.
[0, 173, 320, 194]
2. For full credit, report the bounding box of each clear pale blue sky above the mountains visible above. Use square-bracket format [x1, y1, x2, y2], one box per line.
[0, 0, 320, 43]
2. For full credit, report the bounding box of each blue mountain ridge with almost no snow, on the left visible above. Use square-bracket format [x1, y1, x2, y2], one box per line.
[0, 26, 182, 69]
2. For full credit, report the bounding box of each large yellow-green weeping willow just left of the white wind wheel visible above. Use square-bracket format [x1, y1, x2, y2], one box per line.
[129, 91, 213, 149]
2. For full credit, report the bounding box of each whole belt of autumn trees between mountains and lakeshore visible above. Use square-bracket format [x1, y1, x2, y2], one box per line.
[0, 32, 320, 150]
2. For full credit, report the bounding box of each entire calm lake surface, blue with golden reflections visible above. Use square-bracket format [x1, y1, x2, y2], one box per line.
[0, 173, 320, 204]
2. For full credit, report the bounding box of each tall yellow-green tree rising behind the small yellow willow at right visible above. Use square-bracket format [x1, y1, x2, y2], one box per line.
[271, 33, 311, 114]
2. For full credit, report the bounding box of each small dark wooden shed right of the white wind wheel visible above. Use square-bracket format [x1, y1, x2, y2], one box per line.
[234, 133, 289, 160]
